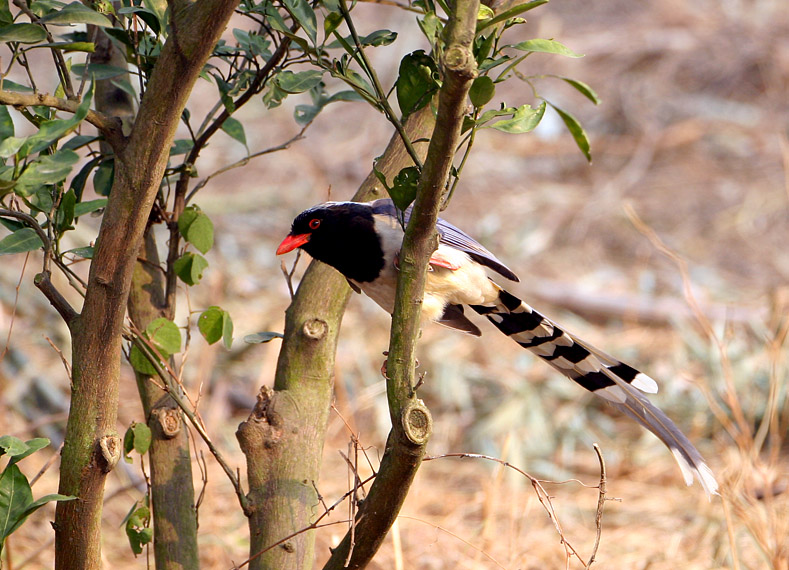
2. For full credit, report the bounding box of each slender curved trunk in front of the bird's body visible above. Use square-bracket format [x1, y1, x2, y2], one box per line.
[324, 0, 479, 570]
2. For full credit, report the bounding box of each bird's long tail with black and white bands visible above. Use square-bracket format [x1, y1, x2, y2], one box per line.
[471, 289, 718, 498]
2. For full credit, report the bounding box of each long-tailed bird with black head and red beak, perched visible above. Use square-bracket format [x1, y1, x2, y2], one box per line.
[276, 198, 718, 499]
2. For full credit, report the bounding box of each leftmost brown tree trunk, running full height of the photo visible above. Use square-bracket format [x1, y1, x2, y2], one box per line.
[55, 0, 237, 570]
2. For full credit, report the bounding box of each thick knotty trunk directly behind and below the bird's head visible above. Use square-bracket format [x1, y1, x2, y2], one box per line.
[236, 107, 434, 570]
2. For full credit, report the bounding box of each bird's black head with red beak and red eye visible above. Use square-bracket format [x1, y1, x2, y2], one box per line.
[277, 202, 384, 282]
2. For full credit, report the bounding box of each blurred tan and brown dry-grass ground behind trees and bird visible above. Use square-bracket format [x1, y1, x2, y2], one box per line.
[0, 0, 789, 570]
